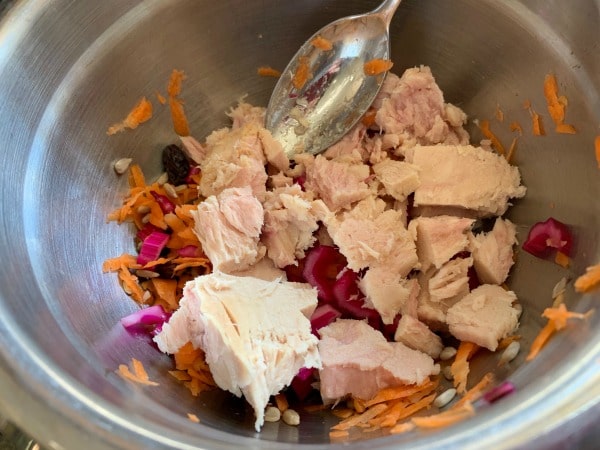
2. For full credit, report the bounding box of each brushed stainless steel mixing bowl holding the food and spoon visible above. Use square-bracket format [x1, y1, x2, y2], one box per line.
[0, 0, 600, 450]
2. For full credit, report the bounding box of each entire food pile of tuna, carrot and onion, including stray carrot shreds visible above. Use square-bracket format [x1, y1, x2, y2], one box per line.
[104, 55, 598, 440]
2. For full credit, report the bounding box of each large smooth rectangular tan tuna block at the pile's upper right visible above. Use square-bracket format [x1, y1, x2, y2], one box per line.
[406, 145, 526, 217]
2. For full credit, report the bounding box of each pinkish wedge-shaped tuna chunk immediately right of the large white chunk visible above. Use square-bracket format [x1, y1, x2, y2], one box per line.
[319, 319, 439, 403]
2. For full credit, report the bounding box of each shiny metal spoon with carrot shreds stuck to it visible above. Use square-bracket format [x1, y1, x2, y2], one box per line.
[266, 0, 401, 157]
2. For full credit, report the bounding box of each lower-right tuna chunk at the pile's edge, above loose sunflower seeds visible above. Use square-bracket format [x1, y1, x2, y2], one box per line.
[447, 284, 519, 351]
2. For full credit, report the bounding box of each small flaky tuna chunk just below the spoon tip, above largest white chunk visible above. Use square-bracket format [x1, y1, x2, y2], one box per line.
[261, 184, 319, 268]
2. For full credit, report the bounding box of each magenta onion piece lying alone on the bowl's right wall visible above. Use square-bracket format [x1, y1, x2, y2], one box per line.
[523, 217, 573, 258]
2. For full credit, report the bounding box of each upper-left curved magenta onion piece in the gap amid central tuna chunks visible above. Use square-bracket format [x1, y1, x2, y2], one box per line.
[302, 244, 347, 303]
